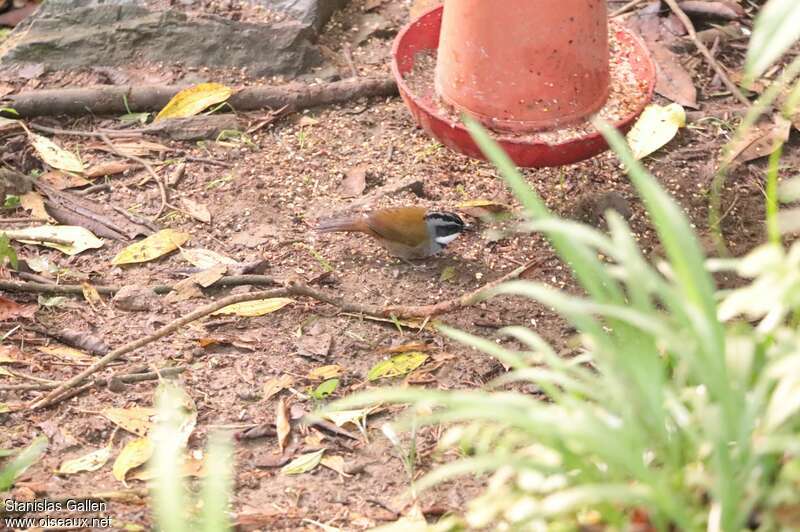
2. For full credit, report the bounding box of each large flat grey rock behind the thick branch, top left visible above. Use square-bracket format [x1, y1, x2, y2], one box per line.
[0, 0, 324, 76]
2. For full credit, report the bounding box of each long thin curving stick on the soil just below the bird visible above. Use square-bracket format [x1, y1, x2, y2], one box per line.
[28, 261, 537, 410]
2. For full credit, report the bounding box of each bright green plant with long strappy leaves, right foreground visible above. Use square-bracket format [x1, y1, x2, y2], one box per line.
[333, 6, 800, 531]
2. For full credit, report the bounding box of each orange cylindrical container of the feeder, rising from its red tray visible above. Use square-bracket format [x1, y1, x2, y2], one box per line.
[436, 0, 609, 132]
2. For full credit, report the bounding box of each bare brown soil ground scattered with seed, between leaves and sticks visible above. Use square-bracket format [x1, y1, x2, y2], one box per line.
[0, 0, 800, 530]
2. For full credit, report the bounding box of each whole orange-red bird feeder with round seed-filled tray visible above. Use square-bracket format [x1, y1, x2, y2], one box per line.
[392, 0, 655, 167]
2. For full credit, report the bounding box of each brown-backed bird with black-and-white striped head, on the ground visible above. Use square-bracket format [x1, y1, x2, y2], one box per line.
[317, 207, 466, 260]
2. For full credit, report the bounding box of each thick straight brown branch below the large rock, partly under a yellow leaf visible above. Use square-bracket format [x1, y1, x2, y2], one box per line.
[0, 76, 397, 118]
